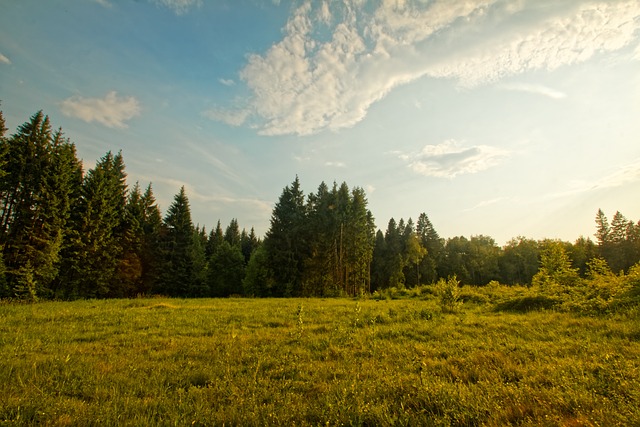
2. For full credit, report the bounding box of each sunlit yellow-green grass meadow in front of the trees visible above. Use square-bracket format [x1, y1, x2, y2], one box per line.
[0, 290, 640, 426]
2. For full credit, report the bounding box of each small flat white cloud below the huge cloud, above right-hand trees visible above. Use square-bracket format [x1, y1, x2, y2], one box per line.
[400, 140, 509, 178]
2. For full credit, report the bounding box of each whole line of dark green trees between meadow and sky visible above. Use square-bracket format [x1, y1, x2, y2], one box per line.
[0, 111, 640, 300]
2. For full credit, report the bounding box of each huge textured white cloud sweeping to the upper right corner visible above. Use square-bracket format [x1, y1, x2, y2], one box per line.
[212, 0, 640, 135]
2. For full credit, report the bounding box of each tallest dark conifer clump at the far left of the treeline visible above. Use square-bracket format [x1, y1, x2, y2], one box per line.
[0, 111, 79, 299]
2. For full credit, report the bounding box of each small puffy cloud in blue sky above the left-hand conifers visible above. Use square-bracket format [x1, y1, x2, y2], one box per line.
[60, 91, 140, 128]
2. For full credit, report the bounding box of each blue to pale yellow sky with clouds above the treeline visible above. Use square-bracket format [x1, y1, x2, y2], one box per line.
[0, 0, 640, 245]
